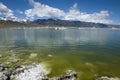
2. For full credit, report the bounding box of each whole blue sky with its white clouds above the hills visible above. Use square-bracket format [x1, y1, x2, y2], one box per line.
[0, 0, 120, 24]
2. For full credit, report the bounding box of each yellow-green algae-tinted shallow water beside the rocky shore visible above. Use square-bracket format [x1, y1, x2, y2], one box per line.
[1, 48, 120, 80]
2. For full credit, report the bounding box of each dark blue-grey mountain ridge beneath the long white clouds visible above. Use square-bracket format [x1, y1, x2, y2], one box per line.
[31, 19, 109, 28]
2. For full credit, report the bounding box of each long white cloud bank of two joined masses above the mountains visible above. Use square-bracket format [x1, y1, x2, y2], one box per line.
[25, 0, 112, 24]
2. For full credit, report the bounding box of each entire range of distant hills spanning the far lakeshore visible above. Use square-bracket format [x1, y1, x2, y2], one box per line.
[0, 19, 120, 28]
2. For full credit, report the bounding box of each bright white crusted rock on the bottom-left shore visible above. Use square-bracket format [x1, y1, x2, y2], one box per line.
[11, 63, 47, 80]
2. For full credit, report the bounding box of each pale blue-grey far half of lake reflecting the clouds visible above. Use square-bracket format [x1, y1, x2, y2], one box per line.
[0, 28, 120, 47]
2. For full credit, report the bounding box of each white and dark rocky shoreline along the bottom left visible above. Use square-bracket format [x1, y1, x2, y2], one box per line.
[0, 63, 77, 80]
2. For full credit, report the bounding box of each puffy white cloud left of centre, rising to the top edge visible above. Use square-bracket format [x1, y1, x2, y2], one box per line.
[25, 0, 65, 18]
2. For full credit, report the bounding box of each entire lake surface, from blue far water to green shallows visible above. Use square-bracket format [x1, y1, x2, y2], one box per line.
[0, 28, 120, 80]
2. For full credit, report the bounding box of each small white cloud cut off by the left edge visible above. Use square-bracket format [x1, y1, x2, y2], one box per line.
[0, 3, 13, 17]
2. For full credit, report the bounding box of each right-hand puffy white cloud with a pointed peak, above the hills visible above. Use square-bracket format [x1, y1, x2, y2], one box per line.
[64, 3, 112, 24]
